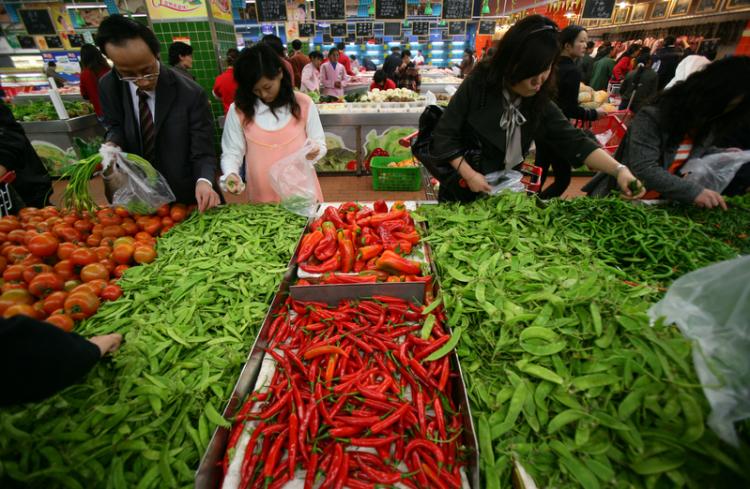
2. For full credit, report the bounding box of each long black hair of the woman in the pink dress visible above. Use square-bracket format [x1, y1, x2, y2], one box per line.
[234, 43, 301, 122]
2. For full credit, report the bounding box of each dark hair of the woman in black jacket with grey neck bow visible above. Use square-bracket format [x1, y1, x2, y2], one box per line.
[470, 15, 560, 111]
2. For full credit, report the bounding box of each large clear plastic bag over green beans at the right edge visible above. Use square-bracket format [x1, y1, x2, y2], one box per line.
[649, 256, 750, 446]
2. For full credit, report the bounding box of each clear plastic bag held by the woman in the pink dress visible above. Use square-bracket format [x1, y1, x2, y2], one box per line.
[269, 139, 320, 217]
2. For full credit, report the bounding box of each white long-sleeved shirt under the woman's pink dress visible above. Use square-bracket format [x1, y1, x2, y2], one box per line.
[221, 99, 327, 175]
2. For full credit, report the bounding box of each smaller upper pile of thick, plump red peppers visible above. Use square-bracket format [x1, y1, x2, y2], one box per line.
[297, 200, 422, 285]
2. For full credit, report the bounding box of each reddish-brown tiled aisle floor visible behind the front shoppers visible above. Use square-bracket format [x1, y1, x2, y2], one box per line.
[52, 176, 589, 205]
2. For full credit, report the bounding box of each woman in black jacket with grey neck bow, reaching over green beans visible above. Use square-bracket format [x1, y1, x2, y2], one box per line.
[430, 15, 635, 202]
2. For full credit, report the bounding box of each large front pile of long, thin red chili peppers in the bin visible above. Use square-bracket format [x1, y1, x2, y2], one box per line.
[224, 296, 465, 489]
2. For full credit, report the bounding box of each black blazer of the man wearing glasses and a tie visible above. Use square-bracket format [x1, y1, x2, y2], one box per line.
[99, 64, 218, 204]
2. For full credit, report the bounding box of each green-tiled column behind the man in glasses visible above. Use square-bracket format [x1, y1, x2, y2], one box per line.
[147, 0, 237, 148]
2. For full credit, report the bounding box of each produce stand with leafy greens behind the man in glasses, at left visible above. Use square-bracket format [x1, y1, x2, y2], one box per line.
[20, 114, 104, 175]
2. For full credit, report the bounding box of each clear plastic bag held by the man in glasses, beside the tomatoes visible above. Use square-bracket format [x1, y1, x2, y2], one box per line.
[99, 144, 175, 214]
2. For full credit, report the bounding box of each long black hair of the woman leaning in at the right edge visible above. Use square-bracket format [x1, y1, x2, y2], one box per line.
[652, 56, 750, 144]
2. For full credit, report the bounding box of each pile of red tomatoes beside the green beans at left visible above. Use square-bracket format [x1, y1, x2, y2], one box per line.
[0, 204, 193, 331]
